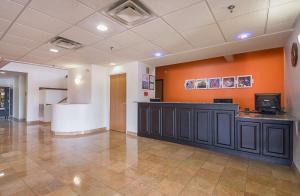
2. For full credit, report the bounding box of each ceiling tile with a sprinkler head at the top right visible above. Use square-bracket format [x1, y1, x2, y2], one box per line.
[207, 0, 269, 21]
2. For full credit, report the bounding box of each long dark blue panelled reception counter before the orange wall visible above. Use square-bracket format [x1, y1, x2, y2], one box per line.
[138, 102, 293, 165]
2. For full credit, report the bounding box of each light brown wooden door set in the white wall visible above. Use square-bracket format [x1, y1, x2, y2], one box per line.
[110, 74, 126, 132]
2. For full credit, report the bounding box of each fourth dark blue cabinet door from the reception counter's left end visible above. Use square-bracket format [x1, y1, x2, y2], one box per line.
[176, 107, 193, 142]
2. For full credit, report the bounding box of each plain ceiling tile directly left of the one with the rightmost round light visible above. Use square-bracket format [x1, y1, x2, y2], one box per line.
[182, 24, 224, 47]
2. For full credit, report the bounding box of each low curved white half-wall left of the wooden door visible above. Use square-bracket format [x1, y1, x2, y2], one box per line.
[51, 104, 102, 135]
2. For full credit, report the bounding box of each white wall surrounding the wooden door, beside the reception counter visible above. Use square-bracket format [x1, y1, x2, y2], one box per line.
[106, 62, 154, 133]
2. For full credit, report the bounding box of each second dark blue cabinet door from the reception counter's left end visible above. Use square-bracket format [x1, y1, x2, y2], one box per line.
[150, 104, 162, 137]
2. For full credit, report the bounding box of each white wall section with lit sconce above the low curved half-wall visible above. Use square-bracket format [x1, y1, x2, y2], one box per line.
[68, 67, 91, 104]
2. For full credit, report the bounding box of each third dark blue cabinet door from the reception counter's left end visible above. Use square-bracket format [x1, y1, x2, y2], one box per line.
[162, 105, 176, 140]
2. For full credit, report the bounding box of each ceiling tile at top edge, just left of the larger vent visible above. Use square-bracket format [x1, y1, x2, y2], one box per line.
[29, 0, 94, 24]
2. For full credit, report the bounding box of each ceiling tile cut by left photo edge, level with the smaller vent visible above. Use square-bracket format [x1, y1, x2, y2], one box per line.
[0, 41, 29, 58]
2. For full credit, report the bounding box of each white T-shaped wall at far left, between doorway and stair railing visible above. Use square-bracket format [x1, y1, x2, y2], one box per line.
[1, 62, 67, 121]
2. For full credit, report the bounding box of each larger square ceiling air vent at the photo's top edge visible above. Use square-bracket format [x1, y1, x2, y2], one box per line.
[102, 0, 155, 27]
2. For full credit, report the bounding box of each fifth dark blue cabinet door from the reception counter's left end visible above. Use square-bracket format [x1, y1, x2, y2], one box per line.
[194, 109, 212, 145]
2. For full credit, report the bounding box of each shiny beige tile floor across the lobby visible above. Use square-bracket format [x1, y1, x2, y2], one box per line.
[0, 122, 300, 196]
